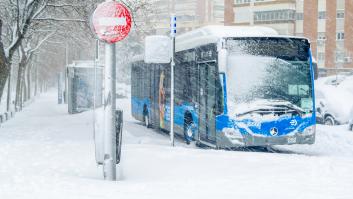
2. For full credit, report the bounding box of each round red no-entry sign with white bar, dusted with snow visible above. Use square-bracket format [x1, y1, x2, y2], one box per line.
[92, 1, 132, 44]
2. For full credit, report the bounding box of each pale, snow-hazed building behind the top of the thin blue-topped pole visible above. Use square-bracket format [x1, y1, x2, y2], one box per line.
[152, 0, 225, 34]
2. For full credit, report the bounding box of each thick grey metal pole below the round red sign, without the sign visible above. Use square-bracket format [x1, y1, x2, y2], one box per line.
[103, 44, 116, 181]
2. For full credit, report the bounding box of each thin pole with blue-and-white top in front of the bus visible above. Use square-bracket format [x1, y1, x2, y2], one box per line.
[170, 15, 176, 146]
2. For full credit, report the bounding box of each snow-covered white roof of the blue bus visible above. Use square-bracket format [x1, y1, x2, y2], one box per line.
[176, 25, 306, 51]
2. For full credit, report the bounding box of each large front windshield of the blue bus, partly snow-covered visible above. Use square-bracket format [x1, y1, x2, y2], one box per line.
[227, 38, 313, 115]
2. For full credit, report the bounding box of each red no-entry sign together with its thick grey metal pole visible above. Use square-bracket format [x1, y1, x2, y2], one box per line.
[91, 1, 132, 180]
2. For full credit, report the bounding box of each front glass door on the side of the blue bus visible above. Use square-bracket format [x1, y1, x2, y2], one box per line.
[198, 62, 216, 144]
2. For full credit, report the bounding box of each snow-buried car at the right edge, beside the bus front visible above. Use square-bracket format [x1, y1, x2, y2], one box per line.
[315, 76, 353, 125]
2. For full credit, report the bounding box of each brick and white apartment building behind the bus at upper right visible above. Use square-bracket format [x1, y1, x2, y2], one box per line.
[224, 0, 353, 68]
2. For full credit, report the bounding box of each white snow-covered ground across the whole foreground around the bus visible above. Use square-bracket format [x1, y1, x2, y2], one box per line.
[0, 91, 353, 199]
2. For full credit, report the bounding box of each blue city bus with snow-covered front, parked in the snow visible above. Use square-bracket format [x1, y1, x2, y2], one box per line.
[131, 26, 316, 148]
